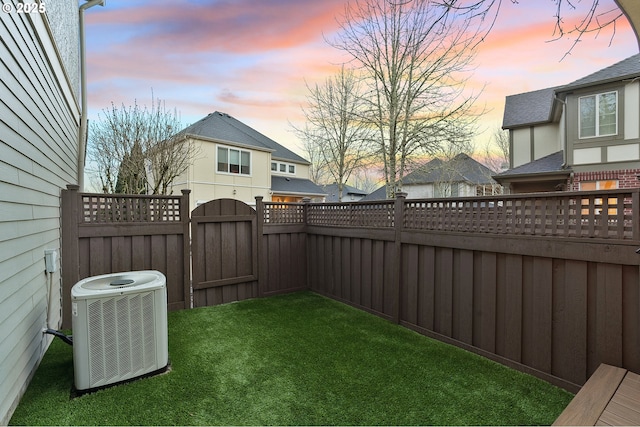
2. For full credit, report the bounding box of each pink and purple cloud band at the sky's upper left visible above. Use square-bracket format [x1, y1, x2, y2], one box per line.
[87, 0, 344, 53]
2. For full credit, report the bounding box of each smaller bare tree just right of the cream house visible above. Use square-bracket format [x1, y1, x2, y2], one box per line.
[296, 65, 373, 201]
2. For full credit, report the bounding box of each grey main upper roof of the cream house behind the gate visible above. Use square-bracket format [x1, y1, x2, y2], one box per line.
[182, 111, 310, 164]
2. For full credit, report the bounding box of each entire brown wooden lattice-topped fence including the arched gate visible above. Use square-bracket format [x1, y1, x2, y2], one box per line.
[62, 187, 640, 391]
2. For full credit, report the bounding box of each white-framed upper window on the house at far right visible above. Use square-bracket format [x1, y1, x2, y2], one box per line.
[579, 92, 618, 138]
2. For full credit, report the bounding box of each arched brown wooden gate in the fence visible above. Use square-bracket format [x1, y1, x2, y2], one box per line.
[191, 199, 259, 307]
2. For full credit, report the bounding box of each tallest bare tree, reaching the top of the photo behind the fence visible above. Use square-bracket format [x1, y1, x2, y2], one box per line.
[332, 0, 479, 197]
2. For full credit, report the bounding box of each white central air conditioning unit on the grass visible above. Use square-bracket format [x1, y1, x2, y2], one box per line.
[71, 270, 169, 394]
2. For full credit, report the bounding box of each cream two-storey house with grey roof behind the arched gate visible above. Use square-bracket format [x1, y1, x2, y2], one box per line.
[173, 111, 326, 205]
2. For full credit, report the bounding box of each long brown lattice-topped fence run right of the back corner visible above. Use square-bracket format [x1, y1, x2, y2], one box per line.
[288, 189, 640, 391]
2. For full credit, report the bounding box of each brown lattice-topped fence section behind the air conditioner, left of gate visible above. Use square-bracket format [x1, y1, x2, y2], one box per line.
[61, 185, 191, 328]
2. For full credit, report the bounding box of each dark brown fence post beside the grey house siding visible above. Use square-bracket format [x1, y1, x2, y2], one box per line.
[60, 184, 82, 329]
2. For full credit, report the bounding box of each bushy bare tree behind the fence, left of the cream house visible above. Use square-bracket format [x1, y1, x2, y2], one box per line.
[88, 96, 197, 194]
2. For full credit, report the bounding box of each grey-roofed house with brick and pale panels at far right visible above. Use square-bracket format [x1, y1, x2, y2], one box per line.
[494, 55, 640, 193]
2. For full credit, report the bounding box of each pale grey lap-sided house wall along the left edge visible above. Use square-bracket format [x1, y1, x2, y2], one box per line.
[0, 0, 80, 425]
